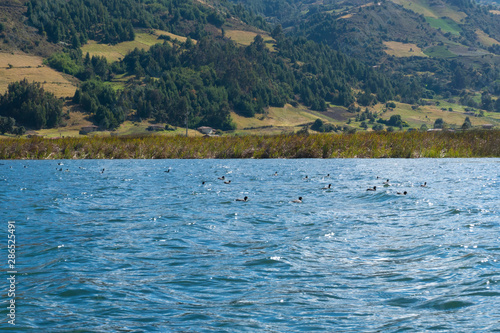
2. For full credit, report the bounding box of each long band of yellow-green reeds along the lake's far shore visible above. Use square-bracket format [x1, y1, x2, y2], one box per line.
[0, 130, 500, 159]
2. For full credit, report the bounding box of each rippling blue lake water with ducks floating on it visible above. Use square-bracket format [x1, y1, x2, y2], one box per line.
[0, 159, 500, 332]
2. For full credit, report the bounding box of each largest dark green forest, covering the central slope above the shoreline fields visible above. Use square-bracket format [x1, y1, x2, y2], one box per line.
[65, 32, 424, 130]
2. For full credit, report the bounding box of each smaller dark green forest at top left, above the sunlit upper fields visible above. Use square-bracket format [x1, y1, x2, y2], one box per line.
[26, 0, 267, 48]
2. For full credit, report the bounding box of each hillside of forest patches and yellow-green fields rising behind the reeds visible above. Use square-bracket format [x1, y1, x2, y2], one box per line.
[0, 0, 500, 136]
